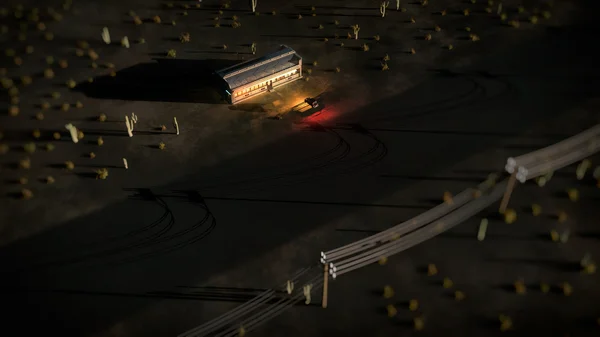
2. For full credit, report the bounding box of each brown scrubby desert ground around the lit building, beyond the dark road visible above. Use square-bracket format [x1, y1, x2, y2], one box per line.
[0, 0, 575, 243]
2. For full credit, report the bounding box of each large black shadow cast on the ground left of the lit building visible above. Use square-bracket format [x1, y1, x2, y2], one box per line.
[75, 59, 238, 104]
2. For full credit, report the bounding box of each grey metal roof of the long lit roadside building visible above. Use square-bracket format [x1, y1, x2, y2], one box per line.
[217, 45, 301, 89]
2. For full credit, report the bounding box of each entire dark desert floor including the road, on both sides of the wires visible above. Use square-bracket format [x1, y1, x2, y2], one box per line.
[0, 1, 600, 337]
